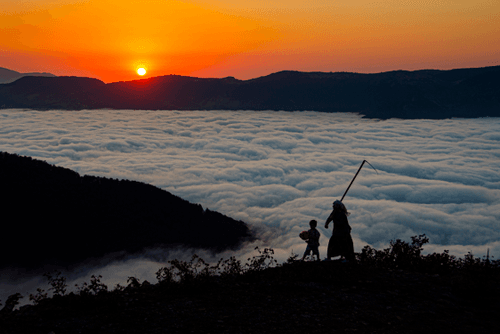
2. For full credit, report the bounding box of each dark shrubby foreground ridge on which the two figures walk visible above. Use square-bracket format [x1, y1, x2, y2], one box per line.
[0, 243, 500, 334]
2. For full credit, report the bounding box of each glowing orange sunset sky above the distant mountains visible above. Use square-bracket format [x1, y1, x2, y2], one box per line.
[0, 0, 500, 82]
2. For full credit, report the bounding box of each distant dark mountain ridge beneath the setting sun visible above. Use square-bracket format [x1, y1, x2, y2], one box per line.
[0, 66, 500, 119]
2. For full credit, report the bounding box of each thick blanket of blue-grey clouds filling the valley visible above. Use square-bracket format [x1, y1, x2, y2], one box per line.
[0, 109, 500, 306]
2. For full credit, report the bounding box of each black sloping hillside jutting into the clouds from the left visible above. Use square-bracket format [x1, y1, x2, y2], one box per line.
[0, 152, 253, 275]
